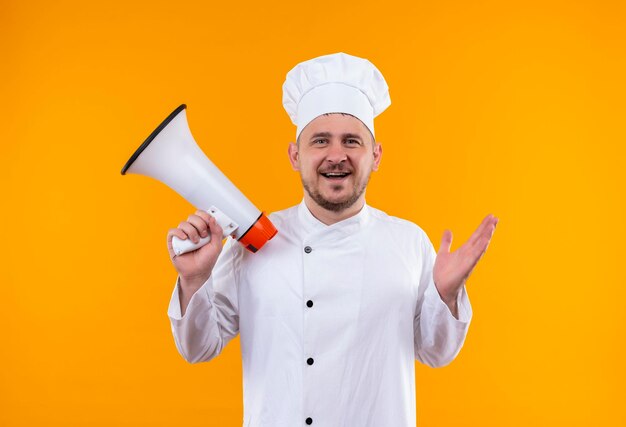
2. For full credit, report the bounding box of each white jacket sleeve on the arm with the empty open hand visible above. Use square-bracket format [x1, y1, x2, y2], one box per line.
[413, 234, 472, 367]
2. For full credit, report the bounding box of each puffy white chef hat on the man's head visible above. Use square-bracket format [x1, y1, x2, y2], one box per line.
[283, 53, 391, 138]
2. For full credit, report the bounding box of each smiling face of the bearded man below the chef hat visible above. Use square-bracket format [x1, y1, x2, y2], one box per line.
[289, 113, 382, 212]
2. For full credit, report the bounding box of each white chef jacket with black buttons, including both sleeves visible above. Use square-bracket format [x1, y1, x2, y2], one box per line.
[168, 201, 472, 427]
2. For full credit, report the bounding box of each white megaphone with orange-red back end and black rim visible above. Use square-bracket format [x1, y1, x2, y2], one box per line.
[122, 104, 277, 255]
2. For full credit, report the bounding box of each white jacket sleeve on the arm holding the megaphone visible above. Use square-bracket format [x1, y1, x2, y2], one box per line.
[167, 238, 243, 363]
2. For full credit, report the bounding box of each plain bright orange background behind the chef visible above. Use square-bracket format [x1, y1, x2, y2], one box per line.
[0, 0, 626, 427]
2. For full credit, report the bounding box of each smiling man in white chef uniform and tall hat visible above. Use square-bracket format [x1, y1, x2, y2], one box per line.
[168, 53, 497, 427]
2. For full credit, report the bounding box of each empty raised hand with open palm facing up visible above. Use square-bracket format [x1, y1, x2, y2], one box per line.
[433, 214, 498, 315]
